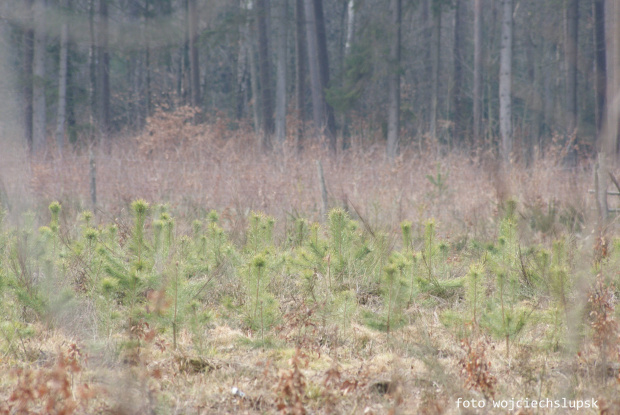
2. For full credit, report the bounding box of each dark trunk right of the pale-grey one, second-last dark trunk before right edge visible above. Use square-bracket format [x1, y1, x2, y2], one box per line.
[565, 0, 579, 136]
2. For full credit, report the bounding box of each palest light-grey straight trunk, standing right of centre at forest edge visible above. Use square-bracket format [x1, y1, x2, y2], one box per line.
[499, 0, 512, 164]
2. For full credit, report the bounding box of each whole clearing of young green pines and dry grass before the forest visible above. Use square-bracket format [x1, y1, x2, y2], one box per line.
[0, 109, 620, 414]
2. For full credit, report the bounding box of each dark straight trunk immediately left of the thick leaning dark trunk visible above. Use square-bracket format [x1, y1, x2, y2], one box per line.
[295, 0, 308, 150]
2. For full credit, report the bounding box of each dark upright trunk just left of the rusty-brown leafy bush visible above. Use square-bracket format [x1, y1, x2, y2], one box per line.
[97, 0, 110, 143]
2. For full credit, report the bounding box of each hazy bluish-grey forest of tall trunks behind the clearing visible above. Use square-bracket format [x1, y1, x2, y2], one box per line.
[0, 0, 618, 161]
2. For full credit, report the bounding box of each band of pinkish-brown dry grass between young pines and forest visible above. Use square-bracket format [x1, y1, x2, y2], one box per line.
[0, 109, 594, 240]
